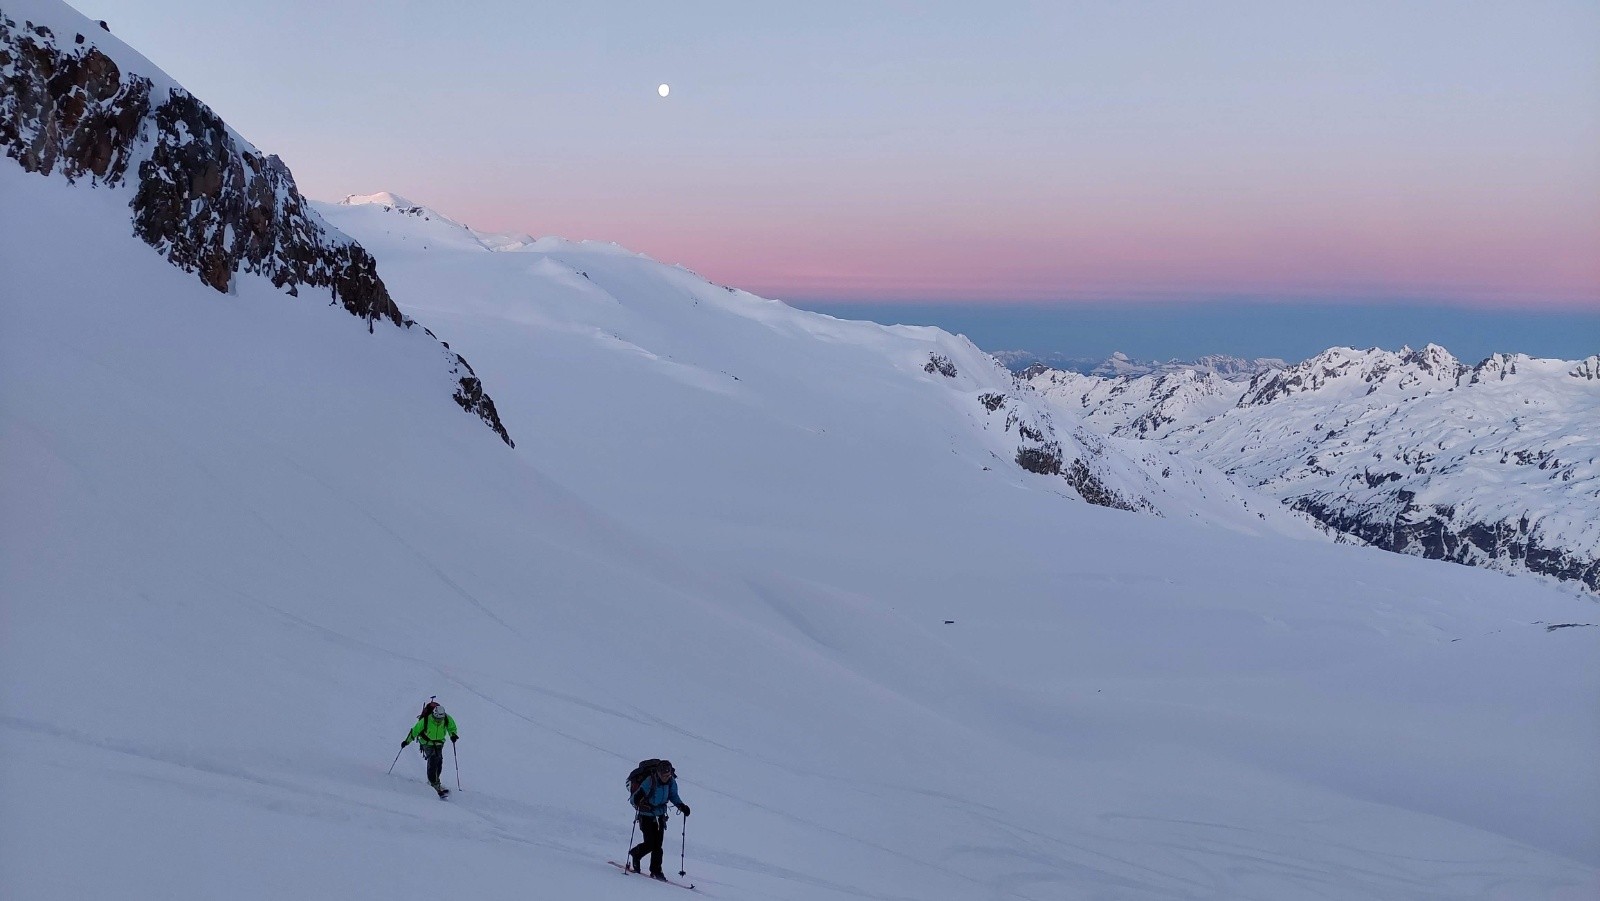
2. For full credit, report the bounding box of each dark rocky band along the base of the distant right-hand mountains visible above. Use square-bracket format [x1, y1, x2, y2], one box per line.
[1290, 490, 1600, 592]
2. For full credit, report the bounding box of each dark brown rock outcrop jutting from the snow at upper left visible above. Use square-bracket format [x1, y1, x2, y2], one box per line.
[0, 13, 515, 446]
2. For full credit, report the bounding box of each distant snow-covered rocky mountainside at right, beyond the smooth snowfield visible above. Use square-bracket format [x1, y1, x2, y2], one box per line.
[1030, 346, 1600, 591]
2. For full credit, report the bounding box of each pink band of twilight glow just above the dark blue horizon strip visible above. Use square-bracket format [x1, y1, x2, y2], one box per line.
[451, 197, 1600, 309]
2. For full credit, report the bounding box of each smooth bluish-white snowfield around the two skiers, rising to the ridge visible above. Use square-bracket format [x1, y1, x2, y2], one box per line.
[0, 0, 1600, 901]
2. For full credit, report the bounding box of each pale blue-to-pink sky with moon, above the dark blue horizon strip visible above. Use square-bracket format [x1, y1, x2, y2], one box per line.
[77, 0, 1600, 360]
